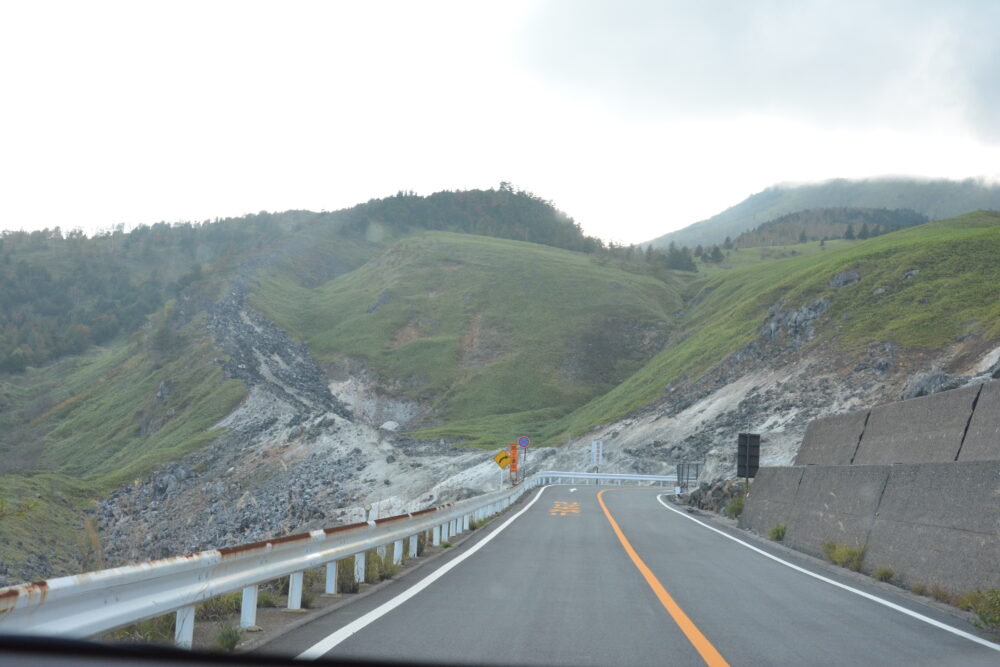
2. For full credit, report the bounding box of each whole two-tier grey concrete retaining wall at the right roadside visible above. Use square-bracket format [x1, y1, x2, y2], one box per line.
[740, 381, 1000, 593]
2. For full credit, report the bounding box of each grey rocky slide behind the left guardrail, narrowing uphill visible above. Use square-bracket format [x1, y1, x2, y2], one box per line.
[96, 284, 498, 564]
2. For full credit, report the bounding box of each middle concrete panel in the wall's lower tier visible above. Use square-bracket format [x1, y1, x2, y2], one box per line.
[784, 465, 889, 557]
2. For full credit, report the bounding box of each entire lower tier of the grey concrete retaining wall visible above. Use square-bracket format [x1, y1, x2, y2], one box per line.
[740, 461, 1000, 593]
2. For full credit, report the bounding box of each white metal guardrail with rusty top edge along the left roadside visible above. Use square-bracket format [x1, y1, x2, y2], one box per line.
[0, 471, 676, 647]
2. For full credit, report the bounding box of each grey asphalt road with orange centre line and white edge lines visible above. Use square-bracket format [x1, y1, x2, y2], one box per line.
[263, 486, 1000, 667]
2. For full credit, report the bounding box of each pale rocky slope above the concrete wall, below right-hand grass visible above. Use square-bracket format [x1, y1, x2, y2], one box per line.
[547, 312, 1000, 483]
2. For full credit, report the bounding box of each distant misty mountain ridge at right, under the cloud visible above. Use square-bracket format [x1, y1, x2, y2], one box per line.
[649, 178, 1000, 248]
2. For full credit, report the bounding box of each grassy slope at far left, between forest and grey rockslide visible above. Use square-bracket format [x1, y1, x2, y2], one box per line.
[0, 314, 245, 571]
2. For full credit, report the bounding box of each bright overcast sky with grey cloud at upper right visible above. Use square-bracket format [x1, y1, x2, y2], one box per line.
[0, 0, 1000, 243]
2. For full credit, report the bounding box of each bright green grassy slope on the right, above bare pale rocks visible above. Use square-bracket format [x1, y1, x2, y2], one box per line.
[547, 212, 1000, 439]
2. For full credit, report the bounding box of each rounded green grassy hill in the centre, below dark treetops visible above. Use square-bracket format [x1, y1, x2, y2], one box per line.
[254, 232, 680, 445]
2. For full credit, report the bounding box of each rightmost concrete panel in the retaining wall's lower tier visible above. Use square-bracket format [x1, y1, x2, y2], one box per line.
[864, 461, 1000, 593]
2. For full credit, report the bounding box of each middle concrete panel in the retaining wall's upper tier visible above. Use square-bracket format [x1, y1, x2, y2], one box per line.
[854, 386, 979, 465]
